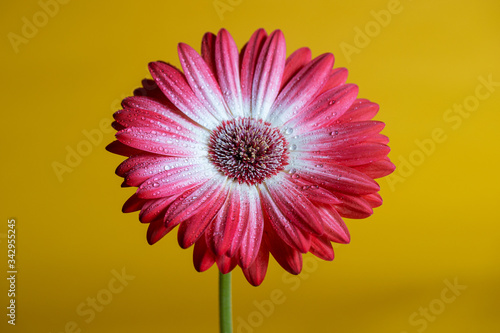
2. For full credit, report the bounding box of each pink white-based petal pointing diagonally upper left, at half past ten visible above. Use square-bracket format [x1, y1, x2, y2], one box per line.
[149, 62, 219, 129]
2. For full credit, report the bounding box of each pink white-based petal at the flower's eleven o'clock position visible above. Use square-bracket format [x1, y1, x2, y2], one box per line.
[178, 43, 231, 121]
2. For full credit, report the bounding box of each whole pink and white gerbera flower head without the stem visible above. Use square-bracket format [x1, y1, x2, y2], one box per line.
[107, 29, 394, 285]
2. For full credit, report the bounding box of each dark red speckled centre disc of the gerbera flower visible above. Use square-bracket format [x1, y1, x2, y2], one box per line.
[208, 118, 288, 185]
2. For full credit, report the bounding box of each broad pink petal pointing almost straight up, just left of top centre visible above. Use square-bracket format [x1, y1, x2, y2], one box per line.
[215, 29, 244, 117]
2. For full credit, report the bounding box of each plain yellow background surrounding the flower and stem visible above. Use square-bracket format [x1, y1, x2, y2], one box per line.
[0, 0, 500, 333]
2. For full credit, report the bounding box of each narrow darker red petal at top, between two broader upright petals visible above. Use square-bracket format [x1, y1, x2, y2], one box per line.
[241, 29, 267, 116]
